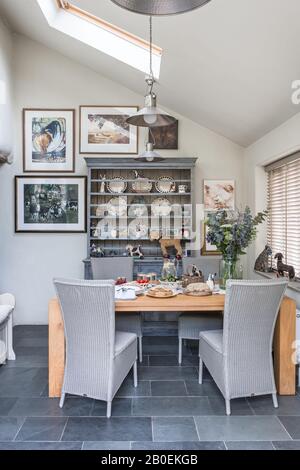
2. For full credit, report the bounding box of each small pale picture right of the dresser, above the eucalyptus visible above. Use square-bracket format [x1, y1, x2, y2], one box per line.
[204, 180, 235, 211]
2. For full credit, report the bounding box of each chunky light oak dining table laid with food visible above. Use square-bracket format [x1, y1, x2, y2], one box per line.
[49, 294, 296, 397]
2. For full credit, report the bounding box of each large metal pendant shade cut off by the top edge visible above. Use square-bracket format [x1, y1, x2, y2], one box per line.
[111, 0, 211, 16]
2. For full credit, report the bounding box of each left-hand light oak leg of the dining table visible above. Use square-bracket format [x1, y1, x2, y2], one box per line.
[49, 300, 65, 398]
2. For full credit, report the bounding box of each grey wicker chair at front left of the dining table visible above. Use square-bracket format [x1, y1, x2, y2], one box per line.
[54, 279, 137, 418]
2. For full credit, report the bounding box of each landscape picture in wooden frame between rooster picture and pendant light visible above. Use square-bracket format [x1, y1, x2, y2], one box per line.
[80, 106, 139, 154]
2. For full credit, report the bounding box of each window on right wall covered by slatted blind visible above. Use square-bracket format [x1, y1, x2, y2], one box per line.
[266, 153, 300, 279]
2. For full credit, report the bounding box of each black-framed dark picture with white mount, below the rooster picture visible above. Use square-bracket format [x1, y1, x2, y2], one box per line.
[15, 176, 87, 233]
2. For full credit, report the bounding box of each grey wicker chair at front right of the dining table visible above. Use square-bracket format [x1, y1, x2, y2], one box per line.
[199, 279, 287, 415]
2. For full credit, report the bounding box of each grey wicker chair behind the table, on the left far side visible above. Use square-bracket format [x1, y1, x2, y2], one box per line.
[91, 257, 143, 362]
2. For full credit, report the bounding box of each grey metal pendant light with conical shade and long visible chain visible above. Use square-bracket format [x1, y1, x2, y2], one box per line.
[126, 16, 176, 127]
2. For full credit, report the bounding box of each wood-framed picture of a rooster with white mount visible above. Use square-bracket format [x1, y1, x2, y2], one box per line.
[23, 109, 75, 173]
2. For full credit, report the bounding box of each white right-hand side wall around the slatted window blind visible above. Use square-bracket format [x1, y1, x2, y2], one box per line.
[244, 113, 300, 306]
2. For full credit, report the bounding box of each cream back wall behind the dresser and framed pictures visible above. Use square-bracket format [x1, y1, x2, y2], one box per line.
[0, 36, 244, 324]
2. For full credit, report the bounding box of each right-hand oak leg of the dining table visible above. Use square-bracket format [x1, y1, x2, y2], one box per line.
[274, 297, 296, 395]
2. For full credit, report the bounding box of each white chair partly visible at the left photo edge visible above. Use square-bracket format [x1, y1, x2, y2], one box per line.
[0, 294, 16, 364]
